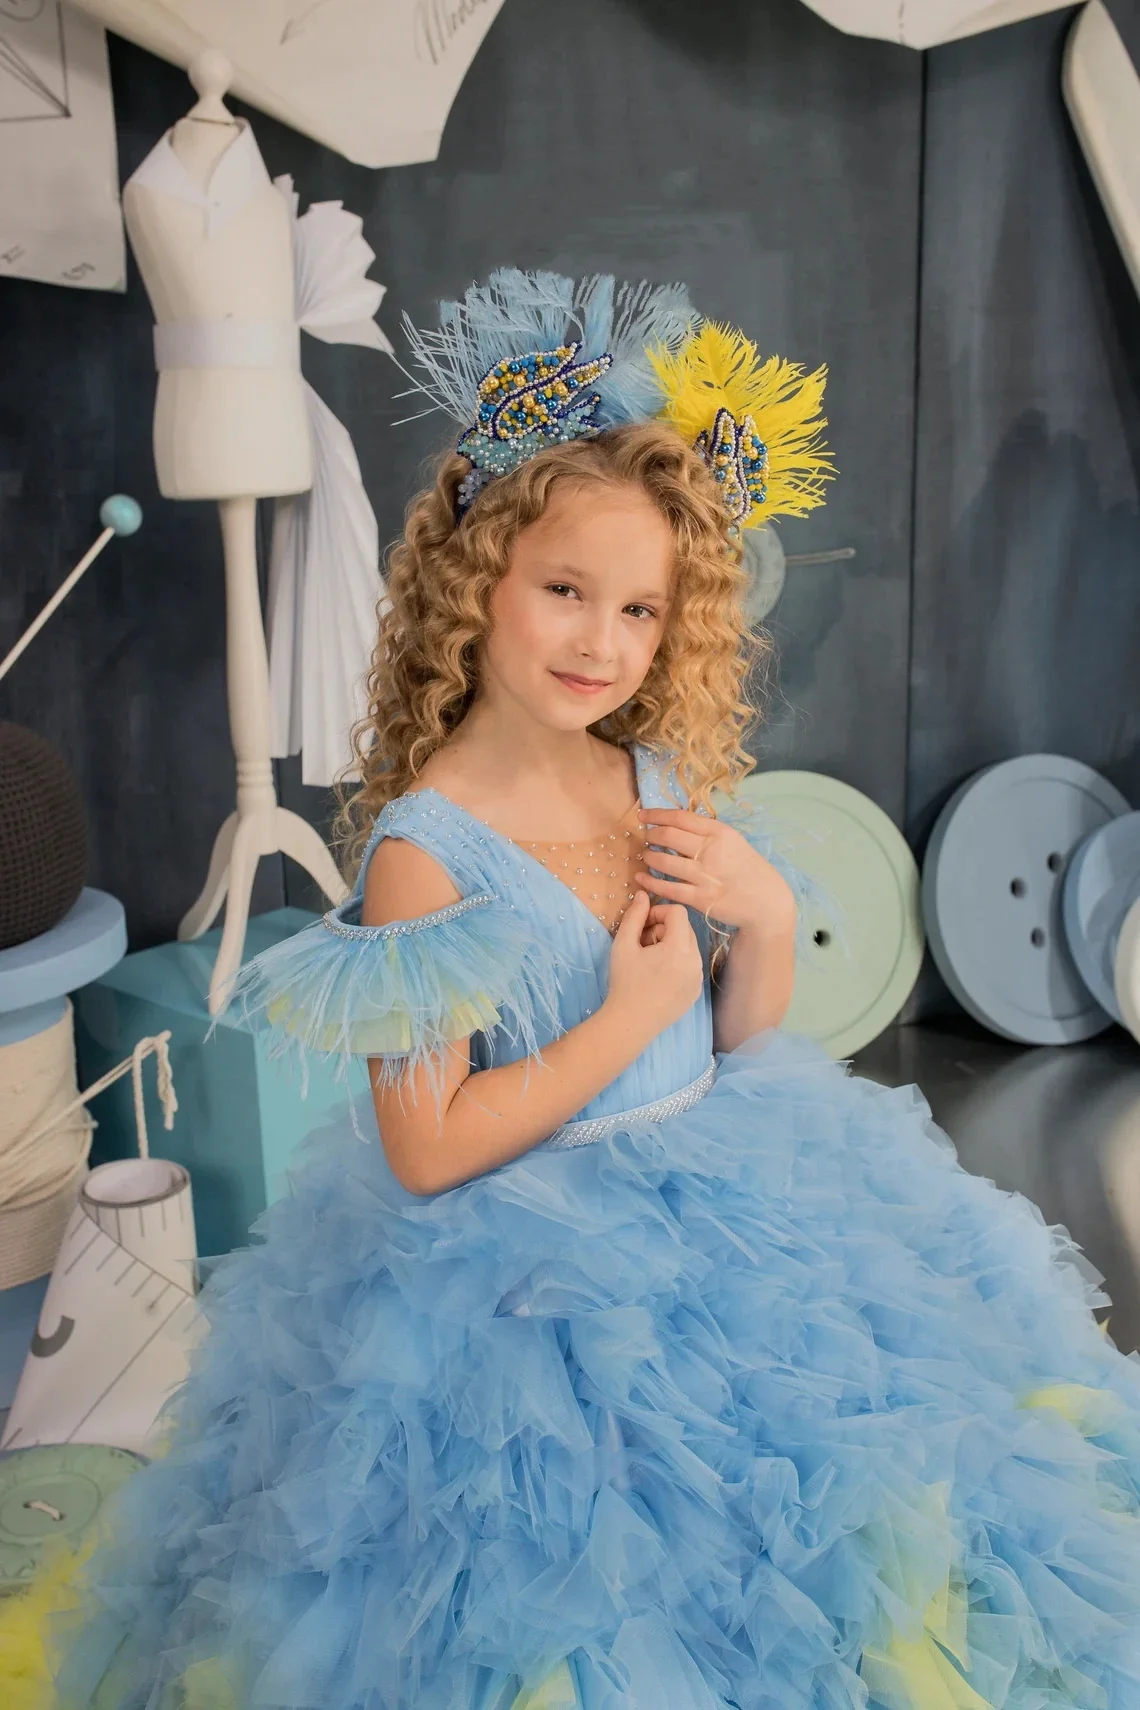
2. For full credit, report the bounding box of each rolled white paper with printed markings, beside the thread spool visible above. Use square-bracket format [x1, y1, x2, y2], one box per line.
[0, 1158, 203, 1454]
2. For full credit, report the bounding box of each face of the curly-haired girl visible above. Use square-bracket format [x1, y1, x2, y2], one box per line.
[482, 482, 673, 730]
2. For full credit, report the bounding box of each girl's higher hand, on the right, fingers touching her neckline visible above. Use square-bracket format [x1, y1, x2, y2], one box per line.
[636, 807, 796, 932]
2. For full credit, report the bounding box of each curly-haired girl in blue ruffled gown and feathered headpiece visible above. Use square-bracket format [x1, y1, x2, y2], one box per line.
[51, 272, 1140, 1710]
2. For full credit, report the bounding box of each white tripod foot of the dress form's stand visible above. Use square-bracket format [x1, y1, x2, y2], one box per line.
[178, 804, 349, 1016]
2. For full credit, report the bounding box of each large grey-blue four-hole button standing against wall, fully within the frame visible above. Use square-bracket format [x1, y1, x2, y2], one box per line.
[923, 754, 1128, 1045]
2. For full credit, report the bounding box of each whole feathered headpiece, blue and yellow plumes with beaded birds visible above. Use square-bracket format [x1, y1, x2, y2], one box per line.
[403, 267, 832, 528]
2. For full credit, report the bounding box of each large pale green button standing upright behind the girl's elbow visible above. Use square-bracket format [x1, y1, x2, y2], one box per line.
[738, 771, 925, 1057]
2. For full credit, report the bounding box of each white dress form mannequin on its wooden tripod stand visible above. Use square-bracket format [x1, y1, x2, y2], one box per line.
[123, 53, 347, 1016]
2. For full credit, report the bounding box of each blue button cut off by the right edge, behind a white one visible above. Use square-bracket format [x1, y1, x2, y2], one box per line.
[1061, 814, 1140, 1021]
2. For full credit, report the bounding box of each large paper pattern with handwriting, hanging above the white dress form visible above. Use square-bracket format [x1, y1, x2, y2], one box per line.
[67, 0, 502, 166]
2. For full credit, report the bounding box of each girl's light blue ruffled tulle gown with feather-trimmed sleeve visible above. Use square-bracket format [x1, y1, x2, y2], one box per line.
[51, 747, 1140, 1710]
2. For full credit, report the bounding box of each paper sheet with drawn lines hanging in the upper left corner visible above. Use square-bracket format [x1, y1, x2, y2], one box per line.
[0, 0, 126, 291]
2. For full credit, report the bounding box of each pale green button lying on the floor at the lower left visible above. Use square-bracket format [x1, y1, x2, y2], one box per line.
[0, 1443, 145, 1594]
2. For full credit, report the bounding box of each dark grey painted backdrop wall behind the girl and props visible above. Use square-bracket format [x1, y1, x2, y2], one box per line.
[0, 0, 1140, 1016]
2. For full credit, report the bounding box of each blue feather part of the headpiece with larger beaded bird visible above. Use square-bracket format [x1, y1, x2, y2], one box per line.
[403, 267, 697, 511]
